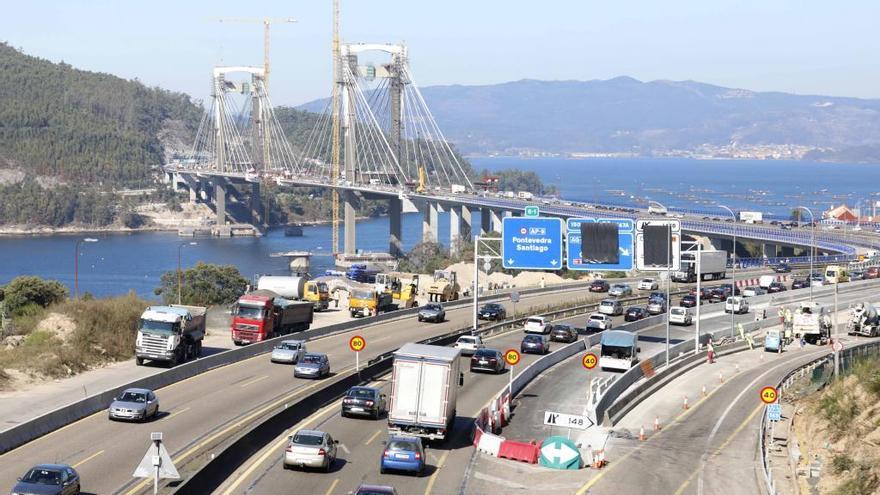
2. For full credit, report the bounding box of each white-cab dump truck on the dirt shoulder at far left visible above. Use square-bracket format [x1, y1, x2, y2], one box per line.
[134, 304, 207, 367]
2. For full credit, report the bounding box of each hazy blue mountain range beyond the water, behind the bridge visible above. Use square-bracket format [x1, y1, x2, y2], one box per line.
[300, 77, 880, 163]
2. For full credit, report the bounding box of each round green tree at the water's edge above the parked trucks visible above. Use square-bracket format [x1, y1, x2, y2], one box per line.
[155, 262, 248, 306]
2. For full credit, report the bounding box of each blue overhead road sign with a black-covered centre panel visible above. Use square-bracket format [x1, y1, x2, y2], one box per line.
[566, 218, 635, 271]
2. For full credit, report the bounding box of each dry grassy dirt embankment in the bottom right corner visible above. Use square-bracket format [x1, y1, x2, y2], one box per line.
[794, 358, 880, 495]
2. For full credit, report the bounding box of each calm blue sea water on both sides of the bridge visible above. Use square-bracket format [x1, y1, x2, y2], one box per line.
[0, 158, 880, 297]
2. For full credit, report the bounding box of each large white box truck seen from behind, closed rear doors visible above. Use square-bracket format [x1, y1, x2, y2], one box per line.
[388, 343, 464, 441]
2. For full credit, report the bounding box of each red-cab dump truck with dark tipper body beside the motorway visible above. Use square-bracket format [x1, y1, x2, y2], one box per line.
[231, 289, 315, 345]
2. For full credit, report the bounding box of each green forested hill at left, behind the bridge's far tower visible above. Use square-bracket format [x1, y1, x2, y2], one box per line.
[0, 44, 201, 184]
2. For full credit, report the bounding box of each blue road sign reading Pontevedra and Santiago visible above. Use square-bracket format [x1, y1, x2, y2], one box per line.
[501, 217, 563, 270]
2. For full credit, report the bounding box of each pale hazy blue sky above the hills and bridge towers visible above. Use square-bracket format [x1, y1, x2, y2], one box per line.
[0, 0, 880, 104]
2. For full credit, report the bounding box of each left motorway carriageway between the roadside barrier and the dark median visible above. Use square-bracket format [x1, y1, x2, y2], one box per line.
[0, 282, 632, 493]
